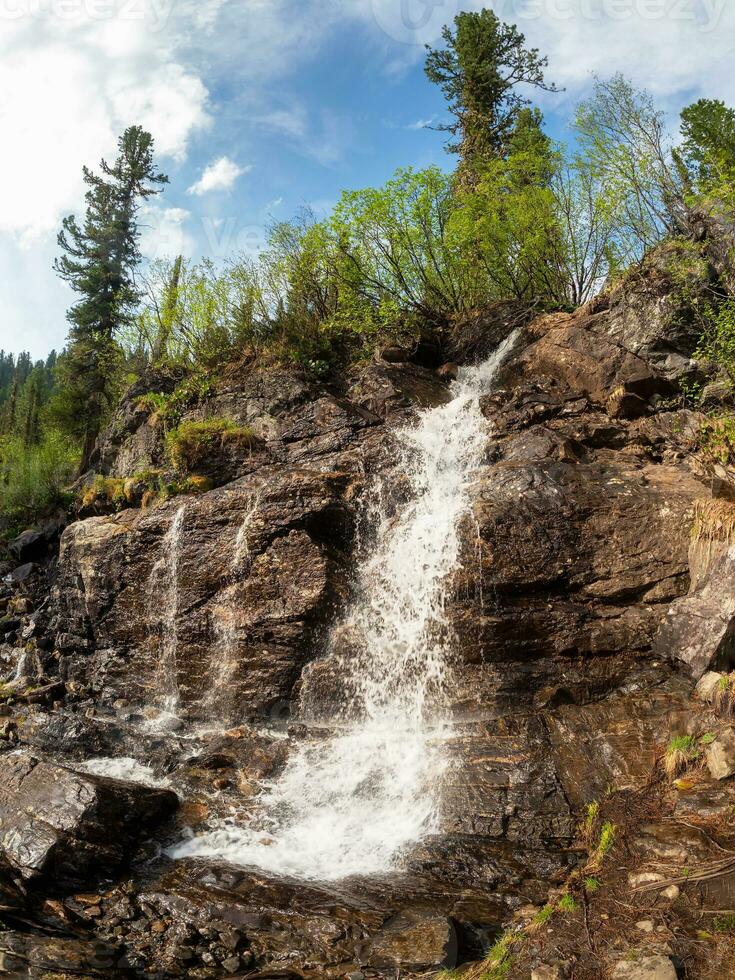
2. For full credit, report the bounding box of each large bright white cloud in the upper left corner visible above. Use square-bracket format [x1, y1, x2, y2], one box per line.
[0, 0, 209, 244]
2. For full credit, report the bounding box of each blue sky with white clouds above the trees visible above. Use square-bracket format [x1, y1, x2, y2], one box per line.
[0, 0, 735, 357]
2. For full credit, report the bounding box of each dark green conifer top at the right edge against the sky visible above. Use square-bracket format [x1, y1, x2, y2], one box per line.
[677, 99, 735, 196]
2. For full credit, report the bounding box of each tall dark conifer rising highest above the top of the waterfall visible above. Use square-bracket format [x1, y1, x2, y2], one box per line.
[425, 10, 557, 183]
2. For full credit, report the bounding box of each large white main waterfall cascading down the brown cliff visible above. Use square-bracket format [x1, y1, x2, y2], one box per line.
[171, 335, 515, 881]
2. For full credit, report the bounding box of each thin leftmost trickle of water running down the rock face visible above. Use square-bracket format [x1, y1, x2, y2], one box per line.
[148, 504, 186, 718]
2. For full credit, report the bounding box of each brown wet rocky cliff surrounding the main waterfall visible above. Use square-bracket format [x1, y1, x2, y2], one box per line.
[0, 229, 735, 980]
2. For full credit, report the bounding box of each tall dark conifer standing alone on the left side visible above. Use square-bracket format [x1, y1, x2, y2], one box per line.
[54, 126, 168, 469]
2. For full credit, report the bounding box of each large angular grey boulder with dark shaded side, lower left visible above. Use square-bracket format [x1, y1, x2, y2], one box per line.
[0, 751, 177, 887]
